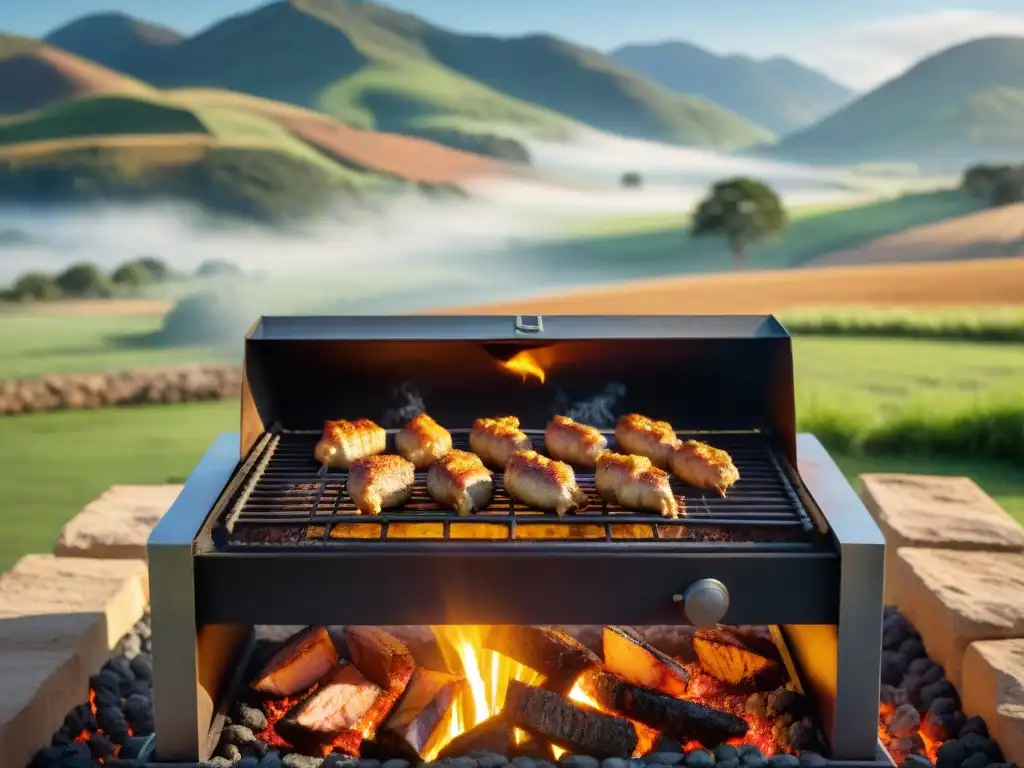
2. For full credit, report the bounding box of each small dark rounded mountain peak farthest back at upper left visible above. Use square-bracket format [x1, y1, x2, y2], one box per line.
[45, 12, 184, 68]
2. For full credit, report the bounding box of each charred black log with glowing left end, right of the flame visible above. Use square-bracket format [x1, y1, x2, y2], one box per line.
[580, 670, 750, 749]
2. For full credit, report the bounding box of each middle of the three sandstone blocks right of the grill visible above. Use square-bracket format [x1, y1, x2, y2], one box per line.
[890, 547, 1024, 687]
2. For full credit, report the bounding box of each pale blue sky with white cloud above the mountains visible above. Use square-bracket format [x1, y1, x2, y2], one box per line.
[6, 0, 1024, 89]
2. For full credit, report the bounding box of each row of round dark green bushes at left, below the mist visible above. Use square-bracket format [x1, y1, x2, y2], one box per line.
[2, 256, 242, 301]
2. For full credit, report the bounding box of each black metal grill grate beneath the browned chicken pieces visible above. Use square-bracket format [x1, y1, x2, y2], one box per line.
[215, 430, 813, 547]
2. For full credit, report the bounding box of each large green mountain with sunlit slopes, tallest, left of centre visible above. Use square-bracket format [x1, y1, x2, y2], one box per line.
[48, 0, 771, 148]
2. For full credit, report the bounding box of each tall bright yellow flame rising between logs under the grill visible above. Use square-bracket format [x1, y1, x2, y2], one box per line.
[425, 626, 541, 763]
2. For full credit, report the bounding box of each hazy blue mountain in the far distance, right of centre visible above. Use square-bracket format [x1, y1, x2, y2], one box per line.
[610, 42, 855, 134]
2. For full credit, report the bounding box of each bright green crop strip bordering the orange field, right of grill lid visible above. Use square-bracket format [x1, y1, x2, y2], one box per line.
[779, 306, 1024, 343]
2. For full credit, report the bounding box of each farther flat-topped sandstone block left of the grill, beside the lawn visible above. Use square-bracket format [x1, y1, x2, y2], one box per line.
[53, 485, 182, 560]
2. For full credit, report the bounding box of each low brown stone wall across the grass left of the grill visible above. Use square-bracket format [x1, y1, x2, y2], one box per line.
[0, 365, 242, 415]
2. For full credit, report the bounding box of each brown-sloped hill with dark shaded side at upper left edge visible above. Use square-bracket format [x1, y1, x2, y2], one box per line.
[0, 35, 153, 116]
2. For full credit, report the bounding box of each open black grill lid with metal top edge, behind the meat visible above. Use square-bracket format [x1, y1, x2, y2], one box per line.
[242, 315, 797, 465]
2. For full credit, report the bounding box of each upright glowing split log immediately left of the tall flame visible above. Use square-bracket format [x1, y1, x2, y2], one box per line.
[377, 667, 466, 762]
